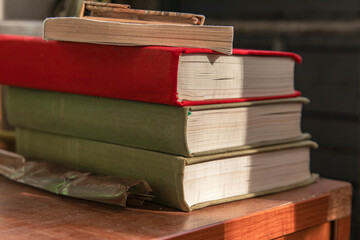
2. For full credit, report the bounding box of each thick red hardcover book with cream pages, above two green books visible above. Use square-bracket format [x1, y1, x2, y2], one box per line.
[0, 35, 301, 106]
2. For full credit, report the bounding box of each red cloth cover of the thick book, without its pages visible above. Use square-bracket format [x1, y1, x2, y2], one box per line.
[0, 35, 301, 106]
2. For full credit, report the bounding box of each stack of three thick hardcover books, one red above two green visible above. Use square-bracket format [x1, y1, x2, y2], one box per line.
[0, 3, 316, 211]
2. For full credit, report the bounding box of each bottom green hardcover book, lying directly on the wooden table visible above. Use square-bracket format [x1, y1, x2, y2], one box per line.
[16, 128, 316, 211]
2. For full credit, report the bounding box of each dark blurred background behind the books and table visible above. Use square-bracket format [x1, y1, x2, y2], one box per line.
[0, 0, 360, 239]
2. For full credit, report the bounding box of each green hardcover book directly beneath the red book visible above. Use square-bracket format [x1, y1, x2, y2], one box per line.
[6, 87, 308, 157]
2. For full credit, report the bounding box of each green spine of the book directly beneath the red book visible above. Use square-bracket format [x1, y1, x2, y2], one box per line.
[6, 87, 190, 156]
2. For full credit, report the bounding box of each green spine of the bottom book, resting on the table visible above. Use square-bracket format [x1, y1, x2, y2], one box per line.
[16, 128, 189, 211]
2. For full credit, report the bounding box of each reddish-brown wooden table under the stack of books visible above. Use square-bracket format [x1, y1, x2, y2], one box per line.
[0, 177, 352, 240]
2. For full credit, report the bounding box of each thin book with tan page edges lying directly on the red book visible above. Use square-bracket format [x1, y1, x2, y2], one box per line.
[44, 17, 233, 55]
